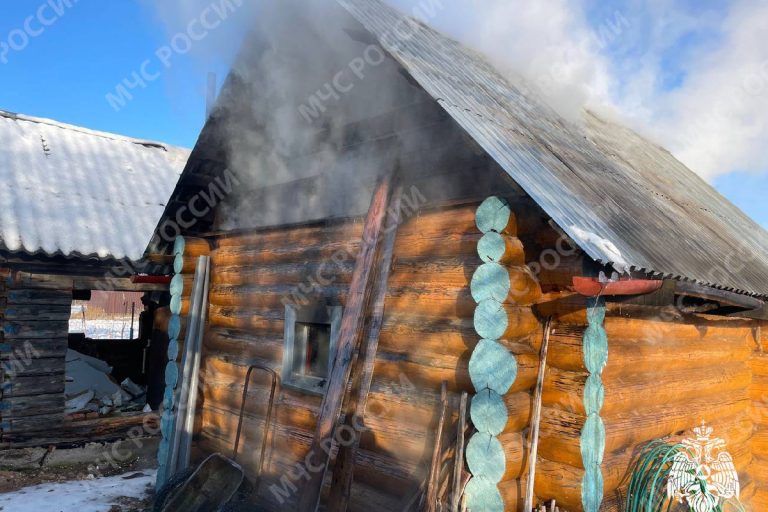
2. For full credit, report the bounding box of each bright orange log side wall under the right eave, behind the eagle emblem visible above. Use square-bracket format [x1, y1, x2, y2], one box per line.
[536, 304, 759, 512]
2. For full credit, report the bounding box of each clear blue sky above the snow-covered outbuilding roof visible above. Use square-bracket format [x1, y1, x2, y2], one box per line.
[0, 0, 240, 147]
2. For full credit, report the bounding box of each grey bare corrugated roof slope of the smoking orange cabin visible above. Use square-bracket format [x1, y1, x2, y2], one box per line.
[337, 0, 768, 295]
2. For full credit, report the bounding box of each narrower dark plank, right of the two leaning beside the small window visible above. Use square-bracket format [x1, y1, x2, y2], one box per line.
[328, 187, 402, 512]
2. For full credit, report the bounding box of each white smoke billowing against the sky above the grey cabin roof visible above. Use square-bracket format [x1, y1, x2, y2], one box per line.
[388, 0, 768, 179]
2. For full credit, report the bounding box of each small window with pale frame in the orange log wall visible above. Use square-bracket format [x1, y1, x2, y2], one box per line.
[283, 304, 341, 394]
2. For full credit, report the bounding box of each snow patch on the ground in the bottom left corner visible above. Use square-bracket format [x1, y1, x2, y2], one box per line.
[0, 470, 156, 512]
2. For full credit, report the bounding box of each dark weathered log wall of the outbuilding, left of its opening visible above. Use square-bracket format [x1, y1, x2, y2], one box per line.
[0, 271, 72, 447]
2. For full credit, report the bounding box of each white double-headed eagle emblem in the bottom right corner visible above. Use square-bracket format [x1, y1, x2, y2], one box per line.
[667, 422, 739, 512]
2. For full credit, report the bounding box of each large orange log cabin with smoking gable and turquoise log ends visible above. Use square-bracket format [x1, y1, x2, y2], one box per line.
[148, 0, 768, 512]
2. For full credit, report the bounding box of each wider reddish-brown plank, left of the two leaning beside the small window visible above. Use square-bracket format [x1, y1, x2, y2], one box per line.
[299, 177, 390, 512]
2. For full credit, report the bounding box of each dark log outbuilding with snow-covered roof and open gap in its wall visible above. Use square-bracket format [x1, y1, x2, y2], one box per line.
[0, 111, 189, 449]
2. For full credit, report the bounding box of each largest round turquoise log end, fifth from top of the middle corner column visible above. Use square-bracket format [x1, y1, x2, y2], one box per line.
[469, 339, 517, 395]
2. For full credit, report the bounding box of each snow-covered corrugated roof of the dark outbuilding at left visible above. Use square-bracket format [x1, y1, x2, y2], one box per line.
[0, 111, 189, 260]
